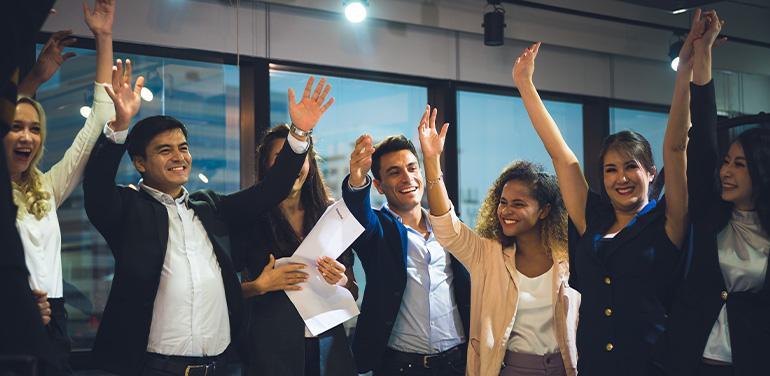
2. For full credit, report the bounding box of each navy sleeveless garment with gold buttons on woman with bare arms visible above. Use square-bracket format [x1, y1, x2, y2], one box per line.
[569, 190, 686, 376]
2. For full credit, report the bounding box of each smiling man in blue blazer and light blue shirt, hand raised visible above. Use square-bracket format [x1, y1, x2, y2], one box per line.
[342, 135, 470, 376]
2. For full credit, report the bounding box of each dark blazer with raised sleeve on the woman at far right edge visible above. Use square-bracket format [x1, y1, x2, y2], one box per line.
[656, 81, 770, 376]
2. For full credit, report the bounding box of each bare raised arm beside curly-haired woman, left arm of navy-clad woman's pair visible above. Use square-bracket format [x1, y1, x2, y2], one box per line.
[513, 42, 588, 235]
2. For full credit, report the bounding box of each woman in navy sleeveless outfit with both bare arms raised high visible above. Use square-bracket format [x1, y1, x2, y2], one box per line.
[513, 11, 703, 376]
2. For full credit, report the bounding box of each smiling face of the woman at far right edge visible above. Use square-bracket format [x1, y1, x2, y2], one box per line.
[719, 141, 754, 210]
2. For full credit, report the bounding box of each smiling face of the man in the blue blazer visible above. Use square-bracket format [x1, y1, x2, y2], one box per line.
[374, 149, 423, 212]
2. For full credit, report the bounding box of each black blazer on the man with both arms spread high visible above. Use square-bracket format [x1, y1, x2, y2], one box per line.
[83, 135, 305, 375]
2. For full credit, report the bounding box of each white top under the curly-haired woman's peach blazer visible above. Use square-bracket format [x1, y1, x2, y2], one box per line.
[507, 266, 559, 355]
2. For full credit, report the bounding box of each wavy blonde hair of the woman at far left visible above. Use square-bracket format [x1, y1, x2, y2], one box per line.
[13, 95, 51, 220]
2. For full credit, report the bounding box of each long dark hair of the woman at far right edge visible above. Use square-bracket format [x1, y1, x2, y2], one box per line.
[735, 128, 770, 234]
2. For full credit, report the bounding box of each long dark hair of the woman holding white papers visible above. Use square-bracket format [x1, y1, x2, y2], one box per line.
[255, 124, 331, 259]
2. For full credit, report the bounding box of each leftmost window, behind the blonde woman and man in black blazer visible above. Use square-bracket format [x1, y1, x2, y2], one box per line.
[37, 45, 240, 350]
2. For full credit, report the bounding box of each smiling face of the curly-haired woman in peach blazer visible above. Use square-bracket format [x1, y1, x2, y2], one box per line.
[497, 179, 550, 237]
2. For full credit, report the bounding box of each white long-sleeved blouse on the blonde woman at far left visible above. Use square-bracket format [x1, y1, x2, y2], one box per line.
[16, 83, 115, 298]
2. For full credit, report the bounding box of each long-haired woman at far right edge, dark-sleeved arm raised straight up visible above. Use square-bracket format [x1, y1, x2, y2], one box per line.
[656, 12, 770, 376]
